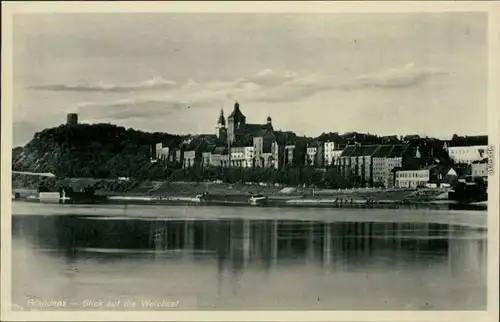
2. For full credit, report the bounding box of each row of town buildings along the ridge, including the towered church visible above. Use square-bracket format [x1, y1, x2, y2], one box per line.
[153, 102, 487, 187]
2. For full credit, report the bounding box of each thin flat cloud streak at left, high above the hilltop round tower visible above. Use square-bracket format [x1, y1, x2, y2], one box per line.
[28, 77, 177, 93]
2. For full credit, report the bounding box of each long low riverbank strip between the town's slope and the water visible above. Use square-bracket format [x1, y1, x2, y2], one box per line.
[13, 178, 487, 210]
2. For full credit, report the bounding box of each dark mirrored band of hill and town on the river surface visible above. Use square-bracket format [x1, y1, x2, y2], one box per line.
[13, 216, 484, 265]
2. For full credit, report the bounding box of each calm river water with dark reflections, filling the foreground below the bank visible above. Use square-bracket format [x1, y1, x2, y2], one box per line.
[12, 203, 487, 310]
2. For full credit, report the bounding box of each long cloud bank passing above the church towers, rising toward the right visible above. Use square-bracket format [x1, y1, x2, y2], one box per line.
[46, 63, 443, 120]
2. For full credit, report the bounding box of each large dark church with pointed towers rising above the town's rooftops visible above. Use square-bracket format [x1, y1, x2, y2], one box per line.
[215, 102, 274, 145]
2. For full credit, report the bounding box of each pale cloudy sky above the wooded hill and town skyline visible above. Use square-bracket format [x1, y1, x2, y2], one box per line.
[12, 13, 488, 145]
